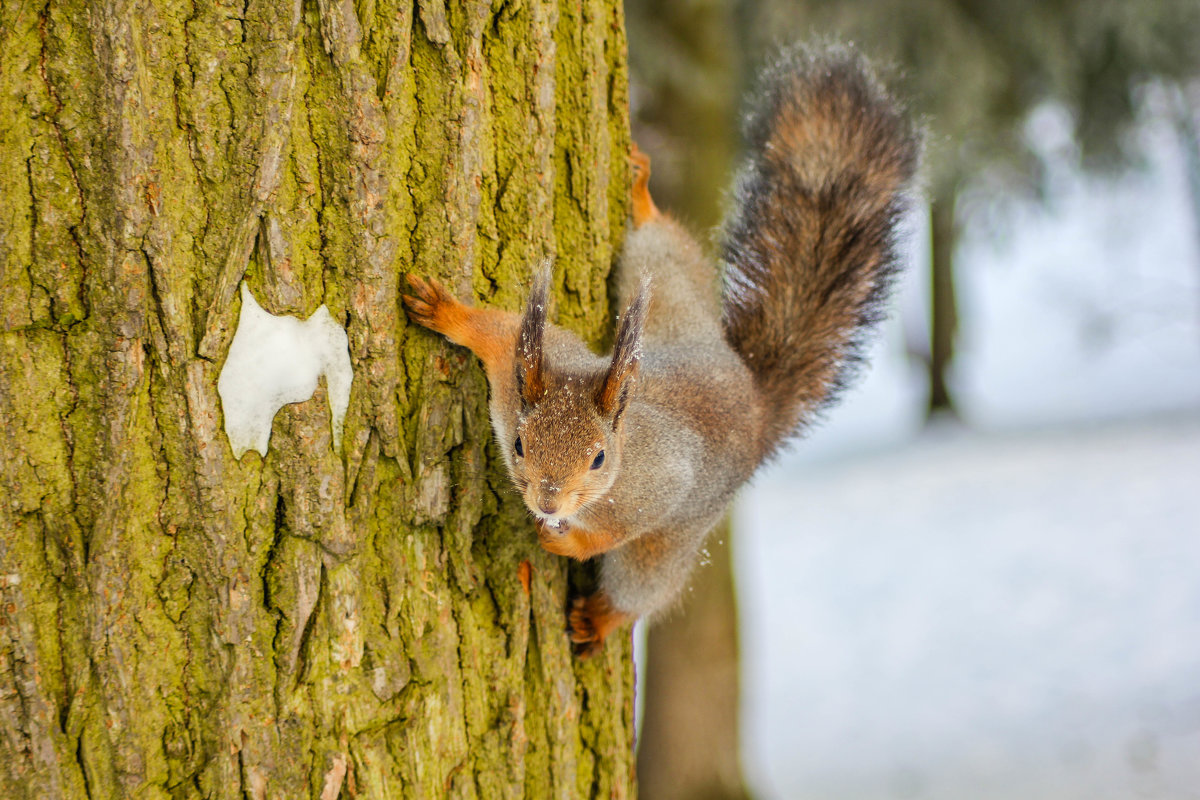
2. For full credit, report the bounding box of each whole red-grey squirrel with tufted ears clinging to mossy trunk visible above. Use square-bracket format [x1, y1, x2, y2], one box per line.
[403, 46, 920, 656]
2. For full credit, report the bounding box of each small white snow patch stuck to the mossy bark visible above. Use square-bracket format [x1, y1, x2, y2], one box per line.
[217, 283, 354, 458]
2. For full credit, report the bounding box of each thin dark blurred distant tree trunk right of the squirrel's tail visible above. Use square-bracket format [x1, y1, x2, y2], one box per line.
[929, 191, 959, 416]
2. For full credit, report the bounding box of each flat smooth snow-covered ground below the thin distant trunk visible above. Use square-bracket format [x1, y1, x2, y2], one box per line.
[737, 415, 1200, 800]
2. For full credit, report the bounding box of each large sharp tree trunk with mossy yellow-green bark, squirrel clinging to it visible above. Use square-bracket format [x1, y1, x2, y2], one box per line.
[0, 0, 632, 800]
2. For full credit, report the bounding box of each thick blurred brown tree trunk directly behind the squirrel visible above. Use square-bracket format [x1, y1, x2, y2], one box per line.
[625, 0, 745, 800]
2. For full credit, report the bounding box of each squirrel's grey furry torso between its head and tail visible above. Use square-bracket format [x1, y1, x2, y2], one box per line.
[583, 218, 761, 616]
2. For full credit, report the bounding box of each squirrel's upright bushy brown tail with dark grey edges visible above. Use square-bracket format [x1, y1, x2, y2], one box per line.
[720, 47, 920, 457]
